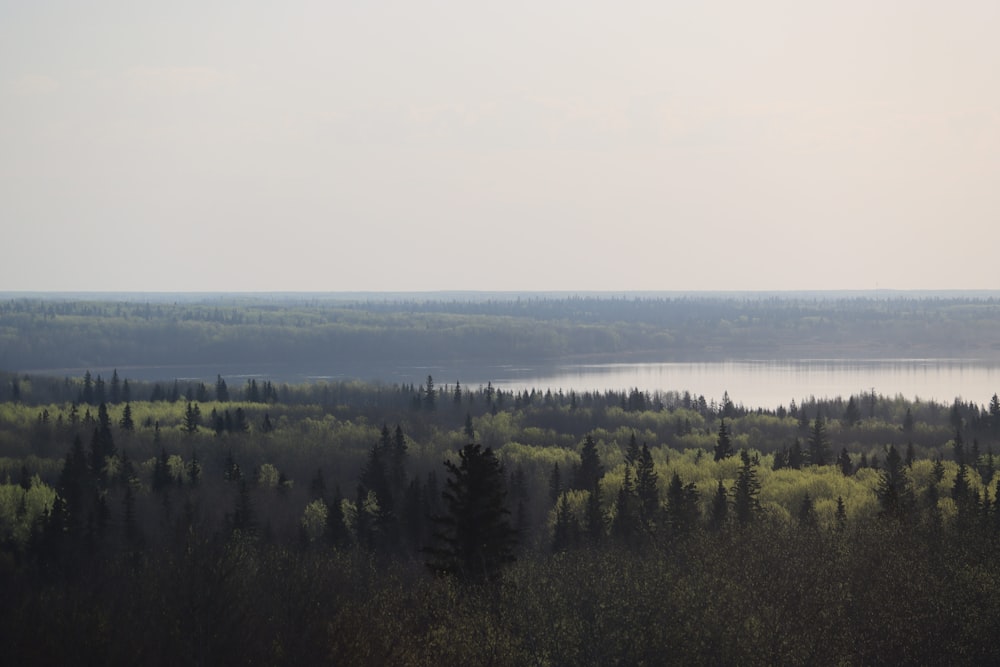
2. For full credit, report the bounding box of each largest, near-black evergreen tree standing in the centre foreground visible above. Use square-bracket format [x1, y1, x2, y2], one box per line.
[427, 444, 517, 581]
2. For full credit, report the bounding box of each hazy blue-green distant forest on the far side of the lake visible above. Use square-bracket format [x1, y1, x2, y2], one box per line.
[0, 295, 1000, 372]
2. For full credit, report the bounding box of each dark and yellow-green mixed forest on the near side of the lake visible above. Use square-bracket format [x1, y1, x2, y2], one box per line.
[0, 366, 1000, 665]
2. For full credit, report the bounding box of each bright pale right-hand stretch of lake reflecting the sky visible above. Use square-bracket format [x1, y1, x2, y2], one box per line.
[484, 359, 1000, 408]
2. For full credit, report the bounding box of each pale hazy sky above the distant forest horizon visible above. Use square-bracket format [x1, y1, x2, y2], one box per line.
[0, 0, 1000, 291]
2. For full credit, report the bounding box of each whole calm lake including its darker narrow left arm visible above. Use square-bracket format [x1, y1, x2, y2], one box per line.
[48, 359, 1000, 408]
